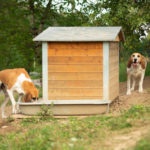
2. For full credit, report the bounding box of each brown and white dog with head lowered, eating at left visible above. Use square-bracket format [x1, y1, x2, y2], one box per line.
[0, 68, 38, 118]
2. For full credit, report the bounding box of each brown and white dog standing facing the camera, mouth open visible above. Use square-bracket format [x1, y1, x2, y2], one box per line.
[127, 53, 147, 95]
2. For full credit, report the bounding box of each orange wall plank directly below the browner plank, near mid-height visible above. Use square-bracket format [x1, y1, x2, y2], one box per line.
[48, 65, 102, 73]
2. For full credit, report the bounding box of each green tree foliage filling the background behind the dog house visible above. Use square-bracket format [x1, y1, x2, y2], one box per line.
[0, 0, 150, 73]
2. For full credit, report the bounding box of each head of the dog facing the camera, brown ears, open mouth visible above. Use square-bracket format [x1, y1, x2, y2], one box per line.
[127, 53, 145, 69]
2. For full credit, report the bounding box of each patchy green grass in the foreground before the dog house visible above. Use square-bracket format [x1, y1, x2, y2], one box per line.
[0, 105, 150, 150]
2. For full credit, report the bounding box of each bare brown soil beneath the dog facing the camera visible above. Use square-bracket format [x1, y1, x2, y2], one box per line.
[110, 77, 150, 114]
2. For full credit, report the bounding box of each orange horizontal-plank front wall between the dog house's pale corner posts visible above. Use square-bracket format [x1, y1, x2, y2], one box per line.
[48, 42, 103, 100]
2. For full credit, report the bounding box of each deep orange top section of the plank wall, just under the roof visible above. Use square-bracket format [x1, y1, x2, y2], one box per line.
[48, 43, 102, 56]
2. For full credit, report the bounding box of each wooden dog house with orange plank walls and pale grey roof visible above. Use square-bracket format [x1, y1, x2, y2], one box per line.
[20, 27, 124, 115]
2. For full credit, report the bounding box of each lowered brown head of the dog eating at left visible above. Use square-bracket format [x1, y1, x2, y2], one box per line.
[23, 81, 39, 102]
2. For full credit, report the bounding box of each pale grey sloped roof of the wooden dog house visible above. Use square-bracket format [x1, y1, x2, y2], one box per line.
[33, 27, 124, 42]
